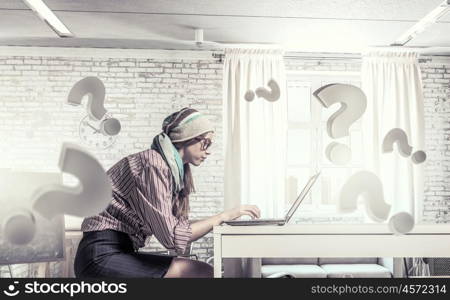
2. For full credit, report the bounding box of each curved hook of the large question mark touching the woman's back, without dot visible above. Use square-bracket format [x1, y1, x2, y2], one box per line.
[32, 143, 112, 219]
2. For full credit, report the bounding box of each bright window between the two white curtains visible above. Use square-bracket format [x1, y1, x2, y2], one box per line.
[285, 73, 363, 219]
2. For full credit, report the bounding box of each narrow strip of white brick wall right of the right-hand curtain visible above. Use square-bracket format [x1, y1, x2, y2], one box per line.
[421, 58, 450, 223]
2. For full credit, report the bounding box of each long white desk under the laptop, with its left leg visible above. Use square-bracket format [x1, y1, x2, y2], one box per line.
[213, 224, 450, 277]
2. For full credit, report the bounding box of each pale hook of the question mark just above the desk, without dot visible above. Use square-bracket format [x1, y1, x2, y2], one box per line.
[338, 171, 391, 222]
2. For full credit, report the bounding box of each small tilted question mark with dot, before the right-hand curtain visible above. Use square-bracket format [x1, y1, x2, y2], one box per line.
[382, 128, 427, 164]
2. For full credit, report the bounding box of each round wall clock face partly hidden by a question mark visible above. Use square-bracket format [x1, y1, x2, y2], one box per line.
[79, 115, 117, 149]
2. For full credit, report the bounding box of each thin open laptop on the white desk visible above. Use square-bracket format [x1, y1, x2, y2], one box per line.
[224, 172, 320, 226]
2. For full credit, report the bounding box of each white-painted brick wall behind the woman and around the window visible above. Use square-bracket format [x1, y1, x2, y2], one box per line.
[0, 49, 450, 277]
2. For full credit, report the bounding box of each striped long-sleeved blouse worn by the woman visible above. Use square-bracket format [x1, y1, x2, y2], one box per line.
[81, 149, 192, 253]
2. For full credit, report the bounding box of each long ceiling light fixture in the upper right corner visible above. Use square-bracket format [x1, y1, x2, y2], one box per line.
[391, 0, 450, 46]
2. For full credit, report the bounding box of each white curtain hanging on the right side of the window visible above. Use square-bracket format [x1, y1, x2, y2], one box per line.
[361, 50, 426, 223]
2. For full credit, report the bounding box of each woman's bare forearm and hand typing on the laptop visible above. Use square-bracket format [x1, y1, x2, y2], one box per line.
[191, 205, 260, 242]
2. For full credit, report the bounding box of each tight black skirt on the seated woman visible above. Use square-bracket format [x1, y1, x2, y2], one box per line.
[74, 229, 173, 278]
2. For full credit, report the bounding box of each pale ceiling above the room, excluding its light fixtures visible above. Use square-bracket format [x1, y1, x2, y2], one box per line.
[0, 0, 450, 54]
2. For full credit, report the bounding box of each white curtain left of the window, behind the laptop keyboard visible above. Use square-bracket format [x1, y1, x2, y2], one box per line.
[223, 49, 287, 217]
